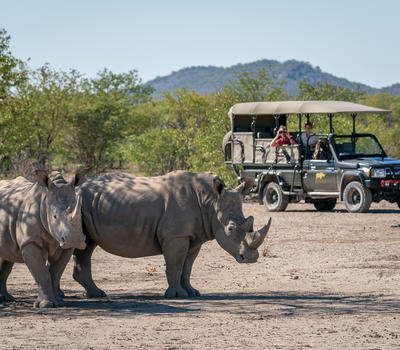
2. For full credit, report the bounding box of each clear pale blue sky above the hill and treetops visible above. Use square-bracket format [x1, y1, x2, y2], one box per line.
[0, 0, 400, 87]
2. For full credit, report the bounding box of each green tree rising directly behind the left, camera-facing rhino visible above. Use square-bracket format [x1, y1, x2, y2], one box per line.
[0, 65, 80, 172]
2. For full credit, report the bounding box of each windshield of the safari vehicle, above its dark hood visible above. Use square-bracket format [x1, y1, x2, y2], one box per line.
[334, 135, 385, 159]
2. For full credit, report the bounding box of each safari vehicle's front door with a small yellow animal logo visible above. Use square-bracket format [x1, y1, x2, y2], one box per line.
[303, 159, 340, 192]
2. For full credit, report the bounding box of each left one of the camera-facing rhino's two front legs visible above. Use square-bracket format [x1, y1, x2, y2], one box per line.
[22, 243, 58, 308]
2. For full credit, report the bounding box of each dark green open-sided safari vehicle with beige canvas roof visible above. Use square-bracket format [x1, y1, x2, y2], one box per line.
[223, 101, 400, 212]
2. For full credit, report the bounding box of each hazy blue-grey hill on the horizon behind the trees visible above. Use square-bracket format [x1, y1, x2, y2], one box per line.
[147, 59, 400, 97]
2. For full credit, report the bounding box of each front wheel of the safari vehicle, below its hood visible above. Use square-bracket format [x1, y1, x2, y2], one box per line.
[343, 181, 372, 213]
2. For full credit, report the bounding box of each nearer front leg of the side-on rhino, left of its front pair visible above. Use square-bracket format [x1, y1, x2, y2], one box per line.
[162, 238, 189, 298]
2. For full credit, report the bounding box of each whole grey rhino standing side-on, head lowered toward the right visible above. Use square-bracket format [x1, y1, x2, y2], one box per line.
[73, 171, 269, 297]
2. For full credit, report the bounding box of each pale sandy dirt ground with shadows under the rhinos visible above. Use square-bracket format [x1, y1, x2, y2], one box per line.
[0, 202, 400, 349]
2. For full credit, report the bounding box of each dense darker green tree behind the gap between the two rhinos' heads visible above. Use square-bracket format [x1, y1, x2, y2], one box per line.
[64, 70, 153, 173]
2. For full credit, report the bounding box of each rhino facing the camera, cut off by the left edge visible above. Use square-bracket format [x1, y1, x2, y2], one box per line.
[0, 172, 86, 307]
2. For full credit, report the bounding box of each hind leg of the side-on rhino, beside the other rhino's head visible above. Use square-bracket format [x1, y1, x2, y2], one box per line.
[72, 239, 107, 298]
